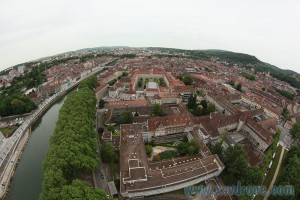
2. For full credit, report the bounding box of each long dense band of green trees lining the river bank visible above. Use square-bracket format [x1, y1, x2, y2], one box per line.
[40, 76, 106, 200]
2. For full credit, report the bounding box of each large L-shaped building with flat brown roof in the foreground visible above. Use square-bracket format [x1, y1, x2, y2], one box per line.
[120, 124, 224, 197]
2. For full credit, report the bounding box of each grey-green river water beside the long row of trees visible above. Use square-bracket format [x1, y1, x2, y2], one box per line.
[8, 96, 66, 200]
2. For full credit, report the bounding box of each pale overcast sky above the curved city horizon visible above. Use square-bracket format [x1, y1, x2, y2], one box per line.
[0, 0, 300, 72]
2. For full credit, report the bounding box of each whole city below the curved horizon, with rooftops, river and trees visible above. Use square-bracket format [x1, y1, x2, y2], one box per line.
[0, 47, 300, 199]
